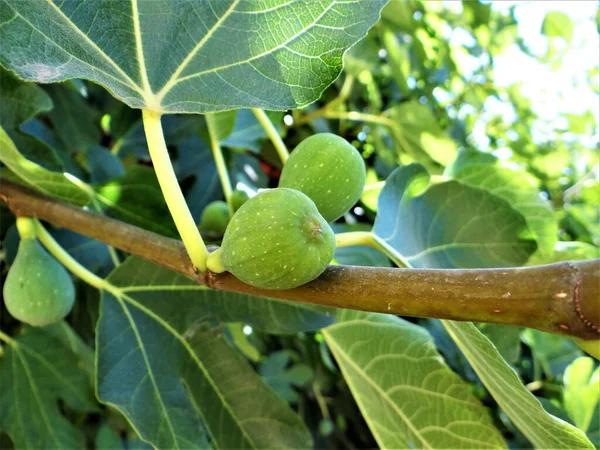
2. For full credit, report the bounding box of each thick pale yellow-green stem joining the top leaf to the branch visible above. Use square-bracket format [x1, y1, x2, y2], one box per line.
[142, 110, 208, 272]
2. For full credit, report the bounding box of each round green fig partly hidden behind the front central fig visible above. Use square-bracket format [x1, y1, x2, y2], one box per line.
[279, 133, 366, 222]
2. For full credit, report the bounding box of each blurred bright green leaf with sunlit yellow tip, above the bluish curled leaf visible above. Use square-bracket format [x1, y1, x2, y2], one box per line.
[392, 100, 457, 165]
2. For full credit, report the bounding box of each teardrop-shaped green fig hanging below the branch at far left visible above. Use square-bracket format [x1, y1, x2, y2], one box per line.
[3, 238, 75, 327]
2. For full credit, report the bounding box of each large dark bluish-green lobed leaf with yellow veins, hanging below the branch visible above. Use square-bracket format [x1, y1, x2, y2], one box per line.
[97, 258, 315, 449]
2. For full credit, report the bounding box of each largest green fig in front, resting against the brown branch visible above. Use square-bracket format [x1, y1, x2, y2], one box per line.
[209, 188, 335, 289]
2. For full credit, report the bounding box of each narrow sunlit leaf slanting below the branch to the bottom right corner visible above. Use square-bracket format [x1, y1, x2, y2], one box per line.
[444, 321, 594, 448]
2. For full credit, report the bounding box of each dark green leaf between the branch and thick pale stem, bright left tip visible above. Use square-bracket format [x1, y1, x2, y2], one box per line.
[94, 166, 179, 237]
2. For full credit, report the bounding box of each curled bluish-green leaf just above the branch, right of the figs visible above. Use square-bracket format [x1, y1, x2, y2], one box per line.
[374, 164, 536, 268]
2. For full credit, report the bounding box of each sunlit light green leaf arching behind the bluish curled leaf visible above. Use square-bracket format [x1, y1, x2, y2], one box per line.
[454, 164, 558, 256]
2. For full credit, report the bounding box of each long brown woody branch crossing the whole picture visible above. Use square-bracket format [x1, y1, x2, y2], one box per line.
[0, 180, 600, 339]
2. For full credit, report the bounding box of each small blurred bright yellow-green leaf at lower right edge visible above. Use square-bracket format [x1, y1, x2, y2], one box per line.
[563, 357, 600, 431]
